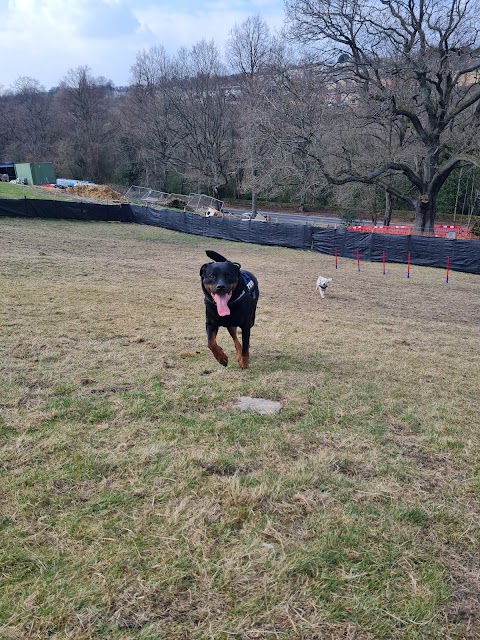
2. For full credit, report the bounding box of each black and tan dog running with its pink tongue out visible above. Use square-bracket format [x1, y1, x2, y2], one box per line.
[200, 251, 259, 369]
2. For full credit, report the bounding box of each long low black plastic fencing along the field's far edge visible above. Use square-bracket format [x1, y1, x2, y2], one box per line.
[0, 199, 480, 274]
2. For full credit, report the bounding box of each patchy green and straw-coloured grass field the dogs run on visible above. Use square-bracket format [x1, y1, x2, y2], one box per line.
[0, 218, 480, 640]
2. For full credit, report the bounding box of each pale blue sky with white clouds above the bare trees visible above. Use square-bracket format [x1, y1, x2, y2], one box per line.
[0, 0, 284, 90]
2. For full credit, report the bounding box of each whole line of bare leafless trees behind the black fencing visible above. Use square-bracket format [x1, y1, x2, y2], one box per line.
[0, 0, 480, 231]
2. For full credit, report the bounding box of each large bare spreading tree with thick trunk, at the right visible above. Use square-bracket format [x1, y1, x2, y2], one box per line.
[286, 0, 480, 231]
